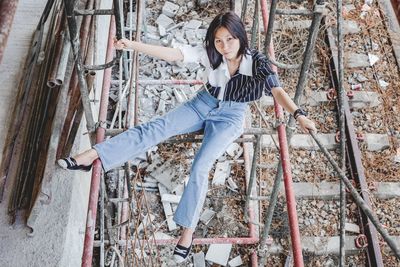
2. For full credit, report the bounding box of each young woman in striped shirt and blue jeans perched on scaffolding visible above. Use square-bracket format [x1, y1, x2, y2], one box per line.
[58, 12, 316, 263]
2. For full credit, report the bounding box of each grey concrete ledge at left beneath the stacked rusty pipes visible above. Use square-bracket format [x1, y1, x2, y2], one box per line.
[0, 0, 111, 267]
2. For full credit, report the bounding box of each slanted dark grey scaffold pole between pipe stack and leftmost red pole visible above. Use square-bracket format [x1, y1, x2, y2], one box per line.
[64, 0, 95, 144]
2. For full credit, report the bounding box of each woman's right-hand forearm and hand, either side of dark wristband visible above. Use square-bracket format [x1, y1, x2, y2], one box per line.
[272, 87, 317, 133]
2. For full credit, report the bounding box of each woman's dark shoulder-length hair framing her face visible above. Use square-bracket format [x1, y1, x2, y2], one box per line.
[204, 11, 249, 69]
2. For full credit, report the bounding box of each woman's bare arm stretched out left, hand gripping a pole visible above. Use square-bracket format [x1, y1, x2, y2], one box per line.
[114, 39, 183, 62]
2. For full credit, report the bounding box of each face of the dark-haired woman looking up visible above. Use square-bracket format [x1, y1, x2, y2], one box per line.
[214, 27, 240, 60]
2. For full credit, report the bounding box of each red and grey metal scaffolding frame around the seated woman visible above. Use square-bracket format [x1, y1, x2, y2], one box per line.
[59, 0, 399, 266]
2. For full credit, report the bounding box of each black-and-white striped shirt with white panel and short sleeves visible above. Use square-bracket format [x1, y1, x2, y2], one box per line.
[178, 46, 281, 102]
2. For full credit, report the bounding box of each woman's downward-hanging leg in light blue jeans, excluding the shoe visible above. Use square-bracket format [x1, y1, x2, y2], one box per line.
[174, 121, 243, 246]
